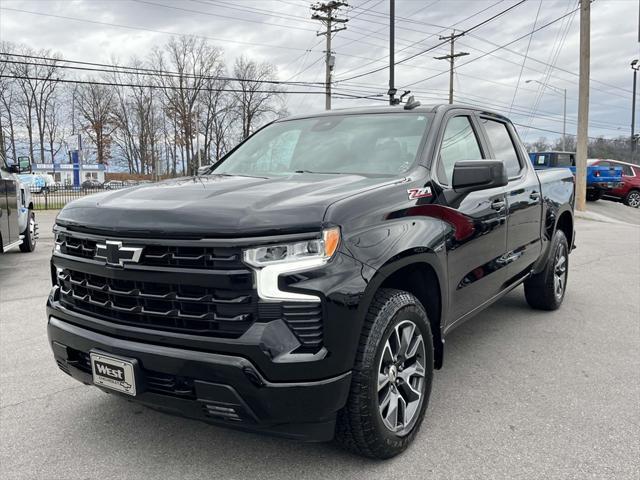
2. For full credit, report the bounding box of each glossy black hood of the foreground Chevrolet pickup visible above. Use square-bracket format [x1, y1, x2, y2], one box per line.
[57, 174, 397, 237]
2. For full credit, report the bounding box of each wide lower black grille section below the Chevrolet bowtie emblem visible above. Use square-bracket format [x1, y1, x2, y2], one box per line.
[58, 269, 256, 338]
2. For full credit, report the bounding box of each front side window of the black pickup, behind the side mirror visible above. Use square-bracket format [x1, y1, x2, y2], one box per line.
[438, 116, 483, 185]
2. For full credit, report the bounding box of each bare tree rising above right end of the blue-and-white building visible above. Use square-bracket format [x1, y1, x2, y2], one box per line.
[76, 83, 117, 163]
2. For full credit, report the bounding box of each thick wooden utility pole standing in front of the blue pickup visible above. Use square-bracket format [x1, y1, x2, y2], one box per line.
[576, 0, 591, 211]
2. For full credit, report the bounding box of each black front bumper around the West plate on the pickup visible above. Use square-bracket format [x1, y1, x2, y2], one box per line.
[47, 316, 351, 441]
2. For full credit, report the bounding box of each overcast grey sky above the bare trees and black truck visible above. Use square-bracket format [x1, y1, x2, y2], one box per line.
[0, 0, 640, 141]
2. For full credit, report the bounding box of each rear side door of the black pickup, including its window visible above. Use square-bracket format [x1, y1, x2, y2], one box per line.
[480, 116, 544, 286]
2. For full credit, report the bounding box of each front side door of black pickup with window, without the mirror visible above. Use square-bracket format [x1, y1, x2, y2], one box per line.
[436, 113, 507, 324]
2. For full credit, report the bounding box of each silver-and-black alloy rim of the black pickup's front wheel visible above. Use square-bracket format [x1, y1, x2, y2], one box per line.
[377, 320, 426, 435]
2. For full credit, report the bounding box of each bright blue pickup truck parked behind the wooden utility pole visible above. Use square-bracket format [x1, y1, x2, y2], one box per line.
[529, 152, 622, 202]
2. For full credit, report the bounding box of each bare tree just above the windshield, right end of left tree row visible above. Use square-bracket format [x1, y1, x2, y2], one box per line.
[233, 56, 283, 139]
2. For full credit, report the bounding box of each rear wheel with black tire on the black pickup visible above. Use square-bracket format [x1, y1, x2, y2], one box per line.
[524, 230, 569, 310]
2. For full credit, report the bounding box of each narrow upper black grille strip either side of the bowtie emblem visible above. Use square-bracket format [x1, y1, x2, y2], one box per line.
[56, 232, 246, 270]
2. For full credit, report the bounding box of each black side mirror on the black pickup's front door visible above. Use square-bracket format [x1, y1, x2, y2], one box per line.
[452, 160, 509, 192]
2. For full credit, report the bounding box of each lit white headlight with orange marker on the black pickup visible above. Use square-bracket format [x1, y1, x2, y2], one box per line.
[244, 227, 340, 302]
